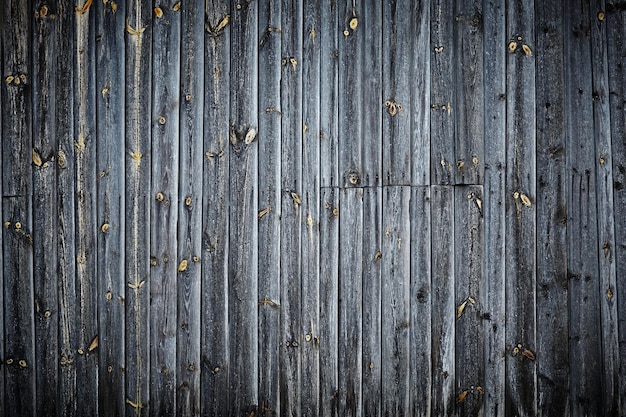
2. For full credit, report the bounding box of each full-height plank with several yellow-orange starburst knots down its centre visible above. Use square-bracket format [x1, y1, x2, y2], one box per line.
[125, 0, 153, 416]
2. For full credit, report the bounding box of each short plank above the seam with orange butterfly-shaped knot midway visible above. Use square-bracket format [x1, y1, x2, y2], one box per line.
[380, 1, 414, 185]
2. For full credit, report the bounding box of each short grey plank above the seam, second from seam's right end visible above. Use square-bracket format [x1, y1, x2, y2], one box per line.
[430, 0, 457, 184]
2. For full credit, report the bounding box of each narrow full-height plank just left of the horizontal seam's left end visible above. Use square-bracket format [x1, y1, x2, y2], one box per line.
[300, 1, 320, 417]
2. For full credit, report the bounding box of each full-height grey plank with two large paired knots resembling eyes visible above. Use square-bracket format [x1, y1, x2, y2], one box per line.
[228, 1, 258, 415]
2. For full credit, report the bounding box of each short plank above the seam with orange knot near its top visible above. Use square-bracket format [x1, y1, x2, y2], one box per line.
[336, 1, 364, 187]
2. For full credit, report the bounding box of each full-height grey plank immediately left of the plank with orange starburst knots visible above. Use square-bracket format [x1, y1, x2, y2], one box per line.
[93, 2, 126, 417]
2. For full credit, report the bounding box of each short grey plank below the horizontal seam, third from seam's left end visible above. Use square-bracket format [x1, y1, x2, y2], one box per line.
[360, 187, 385, 416]
